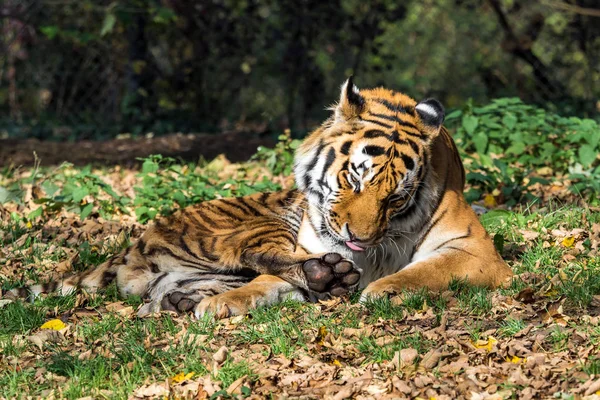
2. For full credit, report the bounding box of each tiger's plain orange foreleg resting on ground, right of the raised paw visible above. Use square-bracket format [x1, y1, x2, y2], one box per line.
[361, 248, 512, 301]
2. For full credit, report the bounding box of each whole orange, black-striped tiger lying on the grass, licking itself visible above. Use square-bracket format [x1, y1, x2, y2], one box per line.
[7, 78, 512, 318]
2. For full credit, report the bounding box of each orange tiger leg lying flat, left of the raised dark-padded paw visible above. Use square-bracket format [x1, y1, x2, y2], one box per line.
[194, 275, 306, 319]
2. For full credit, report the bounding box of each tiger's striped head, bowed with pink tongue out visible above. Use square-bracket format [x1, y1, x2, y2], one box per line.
[294, 78, 444, 251]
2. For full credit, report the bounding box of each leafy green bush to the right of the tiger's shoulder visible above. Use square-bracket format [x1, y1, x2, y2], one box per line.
[447, 98, 600, 205]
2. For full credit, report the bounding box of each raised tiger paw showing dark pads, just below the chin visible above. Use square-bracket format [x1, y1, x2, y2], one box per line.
[302, 253, 362, 296]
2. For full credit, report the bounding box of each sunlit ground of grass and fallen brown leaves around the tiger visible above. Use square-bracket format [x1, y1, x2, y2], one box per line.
[0, 137, 600, 399]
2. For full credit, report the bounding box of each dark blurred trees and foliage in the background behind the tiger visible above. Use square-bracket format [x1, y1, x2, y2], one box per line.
[0, 0, 600, 141]
